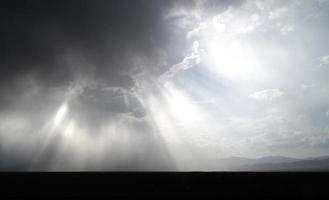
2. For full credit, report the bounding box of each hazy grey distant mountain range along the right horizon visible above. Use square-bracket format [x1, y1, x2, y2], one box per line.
[206, 156, 329, 171]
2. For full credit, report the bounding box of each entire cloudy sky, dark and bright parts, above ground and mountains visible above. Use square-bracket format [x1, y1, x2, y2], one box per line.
[0, 0, 329, 171]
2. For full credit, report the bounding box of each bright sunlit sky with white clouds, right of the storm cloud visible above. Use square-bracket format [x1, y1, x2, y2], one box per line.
[153, 0, 329, 160]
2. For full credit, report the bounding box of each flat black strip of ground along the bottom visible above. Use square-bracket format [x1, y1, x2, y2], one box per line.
[0, 172, 329, 199]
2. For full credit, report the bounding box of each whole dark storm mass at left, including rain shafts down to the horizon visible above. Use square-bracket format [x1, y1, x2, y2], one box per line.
[0, 0, 254, 170]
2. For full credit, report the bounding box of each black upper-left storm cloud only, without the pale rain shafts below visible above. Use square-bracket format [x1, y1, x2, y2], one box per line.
[0, 0, 236, 113]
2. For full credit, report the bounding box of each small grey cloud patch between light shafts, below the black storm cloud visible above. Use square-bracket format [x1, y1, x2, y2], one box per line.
[68, 87, 145, 132]
